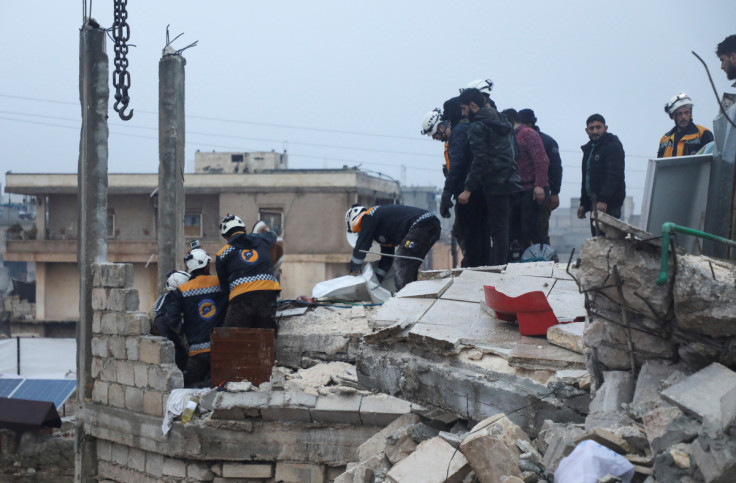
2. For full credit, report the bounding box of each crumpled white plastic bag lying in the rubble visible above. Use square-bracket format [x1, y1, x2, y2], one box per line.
[555, 439, 634, 483]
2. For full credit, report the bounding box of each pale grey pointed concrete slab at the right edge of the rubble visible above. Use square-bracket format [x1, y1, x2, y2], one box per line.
[662, 363, 736, 429]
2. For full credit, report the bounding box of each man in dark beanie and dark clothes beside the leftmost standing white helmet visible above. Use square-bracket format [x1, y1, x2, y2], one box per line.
[440, 97, 491, 267]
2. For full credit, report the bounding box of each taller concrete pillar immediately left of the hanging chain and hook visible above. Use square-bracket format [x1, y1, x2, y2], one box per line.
[74, 23, 110, 481]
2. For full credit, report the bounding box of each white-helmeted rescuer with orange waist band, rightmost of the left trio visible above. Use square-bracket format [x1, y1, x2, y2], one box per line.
[215, 214, 281, 332]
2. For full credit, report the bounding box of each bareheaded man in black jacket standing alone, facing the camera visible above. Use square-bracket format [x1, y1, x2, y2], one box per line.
[578, 114, 626, 236]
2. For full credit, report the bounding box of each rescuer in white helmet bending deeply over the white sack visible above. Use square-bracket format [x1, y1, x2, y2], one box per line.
[345, 205, 442, 291]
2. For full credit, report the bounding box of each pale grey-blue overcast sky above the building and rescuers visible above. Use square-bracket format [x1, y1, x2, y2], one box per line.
[0, 0, 736, 212]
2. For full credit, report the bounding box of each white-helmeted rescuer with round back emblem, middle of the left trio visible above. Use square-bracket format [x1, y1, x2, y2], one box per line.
[160, 240, 227, 387]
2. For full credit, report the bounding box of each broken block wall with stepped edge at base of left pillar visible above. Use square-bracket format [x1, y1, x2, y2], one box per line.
[85, 263, 352, 483]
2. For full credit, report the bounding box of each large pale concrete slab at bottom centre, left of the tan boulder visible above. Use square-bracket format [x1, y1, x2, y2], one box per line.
[386, 436, 470, 483]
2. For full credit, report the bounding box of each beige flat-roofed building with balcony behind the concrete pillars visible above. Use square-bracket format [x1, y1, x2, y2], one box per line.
[5, 165, 401, 326]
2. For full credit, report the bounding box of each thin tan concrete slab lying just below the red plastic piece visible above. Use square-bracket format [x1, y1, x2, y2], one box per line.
[509, 337, 585, 371]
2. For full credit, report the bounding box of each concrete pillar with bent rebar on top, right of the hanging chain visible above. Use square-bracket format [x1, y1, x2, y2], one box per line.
[158, 53, 187, 287]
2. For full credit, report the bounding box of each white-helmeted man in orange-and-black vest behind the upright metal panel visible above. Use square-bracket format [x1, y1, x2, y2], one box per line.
[657, 92, 713, 158]
